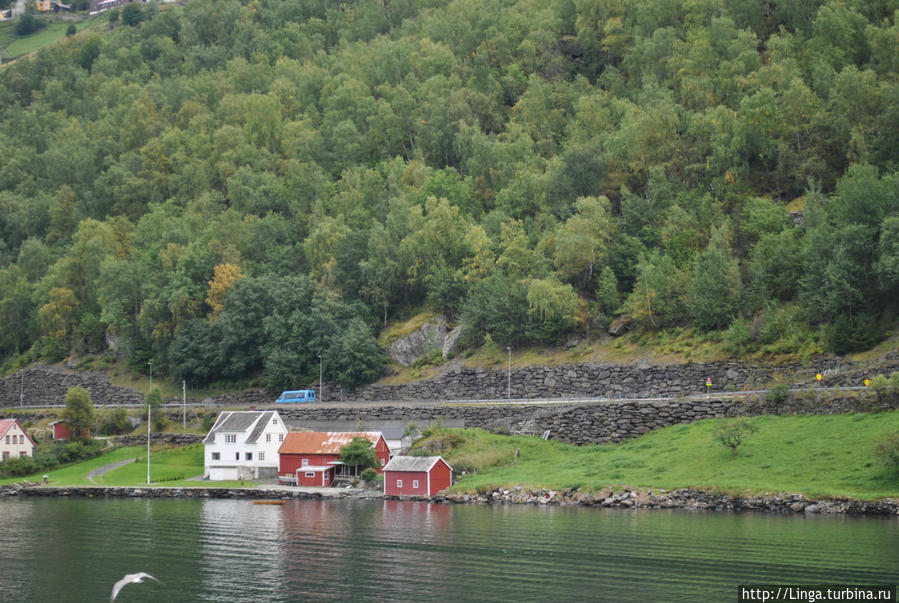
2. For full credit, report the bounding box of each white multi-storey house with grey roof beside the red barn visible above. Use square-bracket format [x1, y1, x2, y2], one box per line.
[203, 410, 287, 480]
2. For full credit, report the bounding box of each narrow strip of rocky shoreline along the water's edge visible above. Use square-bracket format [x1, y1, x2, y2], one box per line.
[0, 485, 899, 516]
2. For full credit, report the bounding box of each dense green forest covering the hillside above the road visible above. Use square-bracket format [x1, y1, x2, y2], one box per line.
[0, 0, 899, 387]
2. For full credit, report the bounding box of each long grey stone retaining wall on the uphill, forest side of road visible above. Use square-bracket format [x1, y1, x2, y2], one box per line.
[0, 353, 899, 408]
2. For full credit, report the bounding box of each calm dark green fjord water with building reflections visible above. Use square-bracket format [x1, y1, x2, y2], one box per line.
[0, 498, 899, 602]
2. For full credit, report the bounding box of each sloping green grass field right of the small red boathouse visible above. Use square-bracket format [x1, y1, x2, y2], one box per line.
[424, 412, 899, 499]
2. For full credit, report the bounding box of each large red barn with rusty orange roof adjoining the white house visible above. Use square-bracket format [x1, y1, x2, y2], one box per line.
[278, 431, 390, 485]
